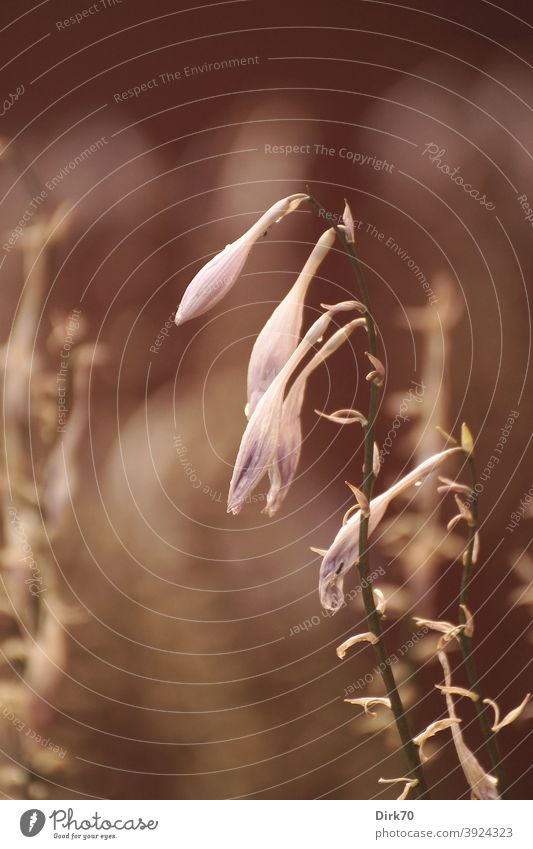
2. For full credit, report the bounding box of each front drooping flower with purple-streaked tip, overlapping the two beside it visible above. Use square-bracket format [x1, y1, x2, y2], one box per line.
[228, 301, 360, 514]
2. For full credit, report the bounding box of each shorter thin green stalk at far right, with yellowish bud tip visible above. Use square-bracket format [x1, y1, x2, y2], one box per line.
[459, 452, 509, 799]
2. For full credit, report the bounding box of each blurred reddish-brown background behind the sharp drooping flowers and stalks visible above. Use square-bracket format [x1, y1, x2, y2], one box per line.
[0, 0, 533, 799]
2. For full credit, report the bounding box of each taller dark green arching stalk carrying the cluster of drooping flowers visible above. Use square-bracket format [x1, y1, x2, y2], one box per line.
[309, 195, 429, 799]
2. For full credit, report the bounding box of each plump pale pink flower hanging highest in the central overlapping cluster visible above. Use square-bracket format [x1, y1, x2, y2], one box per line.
[245, 228, 335, 418]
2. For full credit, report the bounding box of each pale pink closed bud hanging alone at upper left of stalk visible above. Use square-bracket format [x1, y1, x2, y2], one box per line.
[174, 194, 307, 325]
